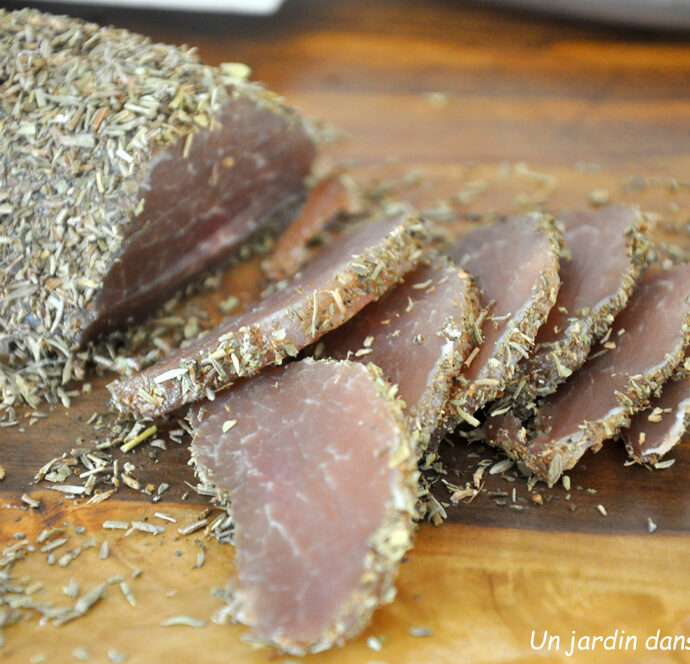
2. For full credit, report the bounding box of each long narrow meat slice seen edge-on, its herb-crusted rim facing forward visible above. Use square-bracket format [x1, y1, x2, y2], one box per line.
[108, 208, 428, 417]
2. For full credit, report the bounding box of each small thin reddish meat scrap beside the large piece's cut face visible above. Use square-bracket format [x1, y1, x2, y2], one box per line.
[262, 174, 361, 281]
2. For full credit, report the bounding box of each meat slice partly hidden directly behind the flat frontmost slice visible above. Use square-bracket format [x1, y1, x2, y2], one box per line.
[323, 260, 478, 452]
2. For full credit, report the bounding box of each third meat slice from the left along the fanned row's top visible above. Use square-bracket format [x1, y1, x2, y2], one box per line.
[440, 214, 561, 424]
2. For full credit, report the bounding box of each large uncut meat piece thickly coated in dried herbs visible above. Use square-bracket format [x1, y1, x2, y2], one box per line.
[0, 10, 315, 384]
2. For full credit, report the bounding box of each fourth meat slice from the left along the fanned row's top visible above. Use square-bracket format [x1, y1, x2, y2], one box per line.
[518, 206, 648, 401]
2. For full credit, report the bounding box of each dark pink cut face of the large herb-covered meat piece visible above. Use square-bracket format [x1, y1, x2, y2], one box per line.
[79, 95, 314, 339]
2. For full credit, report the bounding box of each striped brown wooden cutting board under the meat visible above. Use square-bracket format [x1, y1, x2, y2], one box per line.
[0, 0, 690, 664]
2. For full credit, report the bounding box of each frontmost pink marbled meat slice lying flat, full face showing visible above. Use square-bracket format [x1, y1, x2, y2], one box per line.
[192, 358, 417, 655]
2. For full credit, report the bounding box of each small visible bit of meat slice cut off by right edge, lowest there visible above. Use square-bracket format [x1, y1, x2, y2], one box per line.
[621, 377, 690, 463]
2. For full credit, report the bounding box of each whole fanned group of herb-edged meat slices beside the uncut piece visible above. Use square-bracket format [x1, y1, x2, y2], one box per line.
[111, 200, 690, 654]
